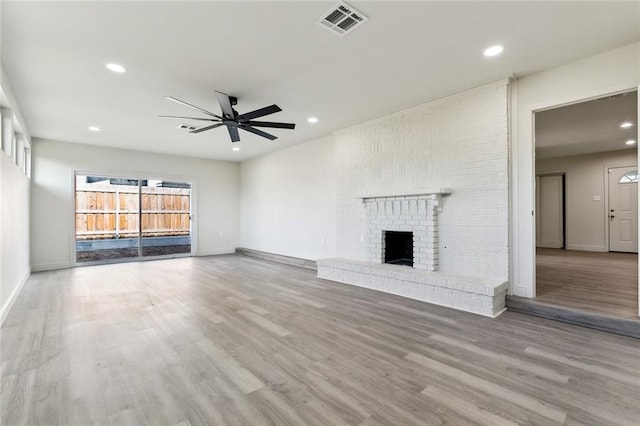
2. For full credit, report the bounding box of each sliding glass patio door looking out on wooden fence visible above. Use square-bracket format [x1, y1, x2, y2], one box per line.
[75, 173, 191, 264]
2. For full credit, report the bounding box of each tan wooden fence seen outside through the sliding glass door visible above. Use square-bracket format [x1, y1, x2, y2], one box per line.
[76, 185, 191, 240]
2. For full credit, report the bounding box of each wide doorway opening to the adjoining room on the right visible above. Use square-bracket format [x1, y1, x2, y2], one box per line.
[534, 91, 639, 320]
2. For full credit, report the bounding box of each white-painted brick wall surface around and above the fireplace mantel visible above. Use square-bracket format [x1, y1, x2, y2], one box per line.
[335, 82, 509, 281]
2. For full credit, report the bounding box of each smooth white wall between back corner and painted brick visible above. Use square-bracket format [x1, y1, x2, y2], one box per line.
[240, 137, 336, 260]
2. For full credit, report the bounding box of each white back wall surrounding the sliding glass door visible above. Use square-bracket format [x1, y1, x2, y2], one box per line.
[31, 139, 240, 270]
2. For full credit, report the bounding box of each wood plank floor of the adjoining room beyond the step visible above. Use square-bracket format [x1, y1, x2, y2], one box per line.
[536, 248, 640, 319]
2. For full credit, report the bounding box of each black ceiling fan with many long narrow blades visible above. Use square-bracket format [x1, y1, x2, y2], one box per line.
[160, 91, 296, 142]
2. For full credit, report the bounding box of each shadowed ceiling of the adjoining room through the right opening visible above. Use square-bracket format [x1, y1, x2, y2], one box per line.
[535, 91, 638, 159]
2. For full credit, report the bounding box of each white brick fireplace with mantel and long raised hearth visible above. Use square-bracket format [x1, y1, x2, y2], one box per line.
[317, 189, 508, 317]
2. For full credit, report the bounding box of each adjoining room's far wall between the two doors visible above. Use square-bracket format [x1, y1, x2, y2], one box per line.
[536, 149, 637, 251]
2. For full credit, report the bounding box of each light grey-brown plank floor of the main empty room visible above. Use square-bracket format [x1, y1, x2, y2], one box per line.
[0, 255, 640, 426]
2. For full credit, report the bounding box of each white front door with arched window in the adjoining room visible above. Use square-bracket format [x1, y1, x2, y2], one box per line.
[609, 166, 638, 253]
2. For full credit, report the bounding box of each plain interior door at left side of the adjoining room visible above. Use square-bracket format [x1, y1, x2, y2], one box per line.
[536, 175, 564, 248]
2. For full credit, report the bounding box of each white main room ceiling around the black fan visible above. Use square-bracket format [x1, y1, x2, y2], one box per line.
[1, 1, 640, 160]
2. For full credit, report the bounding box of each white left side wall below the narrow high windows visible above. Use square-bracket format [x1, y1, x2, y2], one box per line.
[0, 151, 31, 324]
